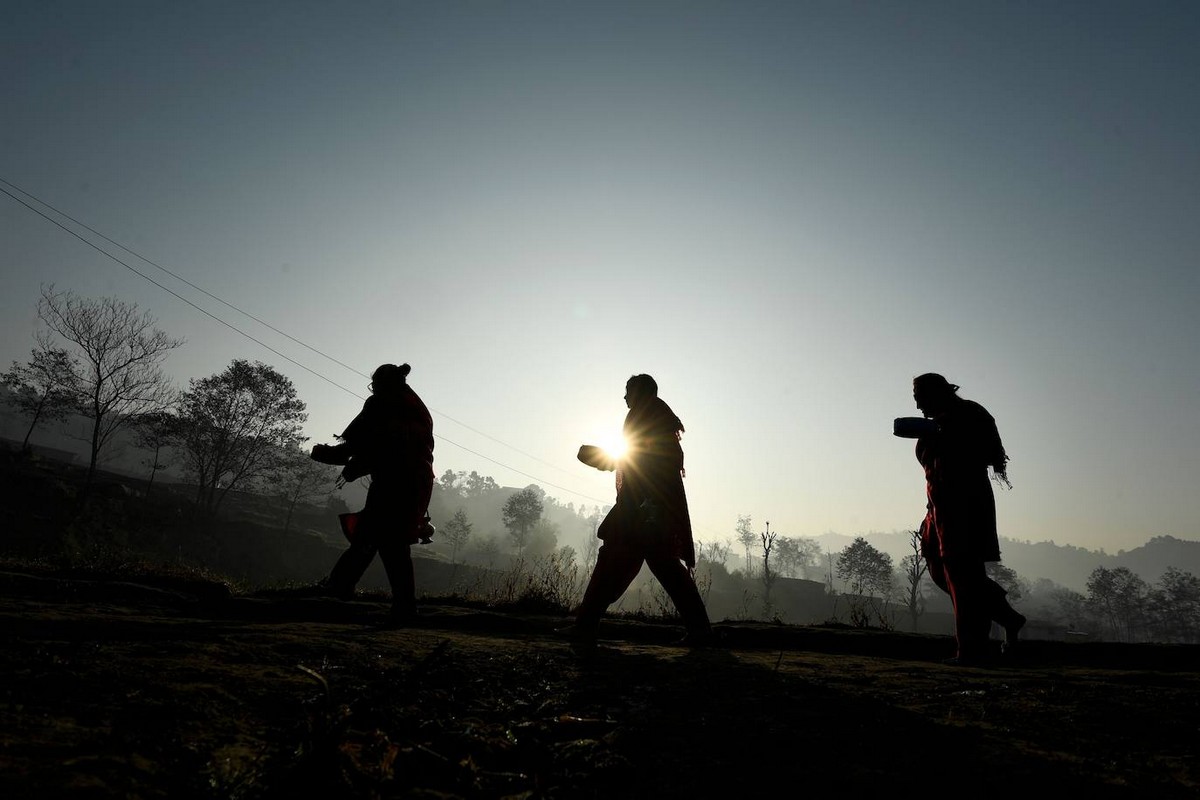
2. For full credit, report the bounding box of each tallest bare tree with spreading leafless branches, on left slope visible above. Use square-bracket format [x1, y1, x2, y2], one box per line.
[37, 285, 184, 492]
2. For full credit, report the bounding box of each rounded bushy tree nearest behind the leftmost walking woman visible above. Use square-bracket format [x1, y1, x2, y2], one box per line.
[179, 359, 308, 513]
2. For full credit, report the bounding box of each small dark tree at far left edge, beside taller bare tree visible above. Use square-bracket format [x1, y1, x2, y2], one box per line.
[0, 331, 79, 451]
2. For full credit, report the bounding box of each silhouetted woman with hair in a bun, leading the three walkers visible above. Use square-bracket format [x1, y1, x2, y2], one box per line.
[312, 363, 433, 625]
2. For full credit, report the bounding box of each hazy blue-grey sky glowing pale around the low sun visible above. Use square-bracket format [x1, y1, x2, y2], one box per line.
[0, 0, 1200, 553]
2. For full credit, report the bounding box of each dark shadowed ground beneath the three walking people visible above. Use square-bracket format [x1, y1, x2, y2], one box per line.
[0, 572, 1200, 799]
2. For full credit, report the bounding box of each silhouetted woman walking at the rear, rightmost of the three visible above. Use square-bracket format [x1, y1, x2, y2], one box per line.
[896, 372, 1025, 664]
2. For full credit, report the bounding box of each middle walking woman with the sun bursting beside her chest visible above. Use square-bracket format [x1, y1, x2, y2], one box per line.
[571, 375, 713, 645]
